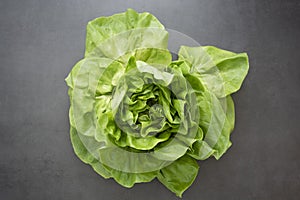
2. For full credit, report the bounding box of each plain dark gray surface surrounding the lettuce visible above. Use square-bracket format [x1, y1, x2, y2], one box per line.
[0, 0, 300, 200]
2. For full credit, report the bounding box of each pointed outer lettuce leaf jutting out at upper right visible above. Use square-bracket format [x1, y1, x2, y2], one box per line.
[179, 46, 249, 98]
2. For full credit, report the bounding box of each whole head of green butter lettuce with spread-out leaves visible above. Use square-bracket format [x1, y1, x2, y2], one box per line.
[66, 9, 249, 197]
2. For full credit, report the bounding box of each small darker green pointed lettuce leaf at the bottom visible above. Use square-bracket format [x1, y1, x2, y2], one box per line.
[157, 155, 199, 197]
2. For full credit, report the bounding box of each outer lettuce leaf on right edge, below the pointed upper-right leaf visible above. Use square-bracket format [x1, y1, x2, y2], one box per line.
[189, 94, 234, 160]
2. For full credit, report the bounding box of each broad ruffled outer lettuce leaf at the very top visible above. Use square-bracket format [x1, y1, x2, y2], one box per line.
[85, 9, 168, 58]
